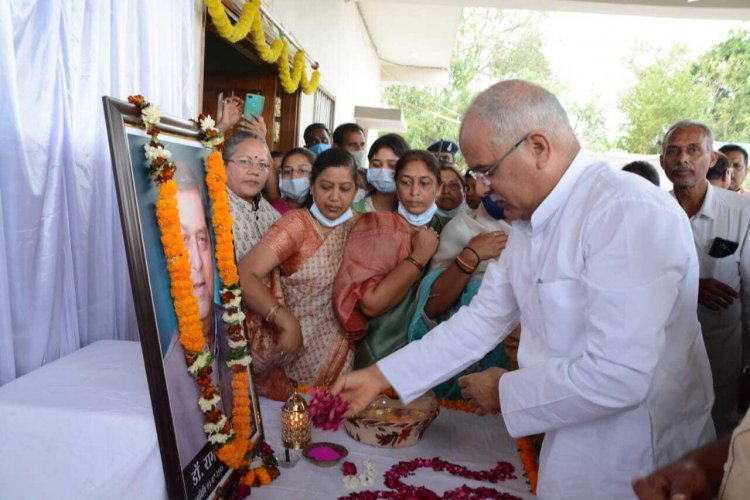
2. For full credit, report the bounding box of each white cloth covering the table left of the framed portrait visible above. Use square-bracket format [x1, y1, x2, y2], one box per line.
[0, 340, 166, 499]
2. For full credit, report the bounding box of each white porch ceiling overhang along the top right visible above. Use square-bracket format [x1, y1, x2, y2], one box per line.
[356, 0, 750, 85]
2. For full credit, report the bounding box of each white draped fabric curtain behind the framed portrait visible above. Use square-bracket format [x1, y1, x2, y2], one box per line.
[0, 0, 201, 385]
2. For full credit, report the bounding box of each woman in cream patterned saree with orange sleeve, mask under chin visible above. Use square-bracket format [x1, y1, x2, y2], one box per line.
[239, 148, 358, 399]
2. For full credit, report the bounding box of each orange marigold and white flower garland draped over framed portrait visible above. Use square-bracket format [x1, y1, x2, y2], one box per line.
[128, 96, 278, 486]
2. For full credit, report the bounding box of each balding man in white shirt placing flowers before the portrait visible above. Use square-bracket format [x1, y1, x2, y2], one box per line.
[333, 81, 713, 499]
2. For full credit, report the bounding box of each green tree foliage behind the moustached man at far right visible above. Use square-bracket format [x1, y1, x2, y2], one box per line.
[617, 30, 750, 153]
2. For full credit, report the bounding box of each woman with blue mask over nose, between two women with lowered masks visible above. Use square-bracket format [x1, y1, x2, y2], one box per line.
[352, 134, 409, 212]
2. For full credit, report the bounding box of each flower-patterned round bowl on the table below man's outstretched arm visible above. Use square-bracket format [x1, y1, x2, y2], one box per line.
[343, 391, 440, 448]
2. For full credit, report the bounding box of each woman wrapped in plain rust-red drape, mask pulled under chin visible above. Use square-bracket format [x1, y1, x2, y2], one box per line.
[333, 150, 447, 368]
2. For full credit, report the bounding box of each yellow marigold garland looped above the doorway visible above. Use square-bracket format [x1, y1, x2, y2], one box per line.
[204, 0, 320, 94]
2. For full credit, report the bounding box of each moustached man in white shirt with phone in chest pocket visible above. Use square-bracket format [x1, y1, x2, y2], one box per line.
[660, 121, 750, 435]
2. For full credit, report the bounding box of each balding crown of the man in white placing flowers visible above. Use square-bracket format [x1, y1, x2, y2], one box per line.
[461, 80, 578, 150]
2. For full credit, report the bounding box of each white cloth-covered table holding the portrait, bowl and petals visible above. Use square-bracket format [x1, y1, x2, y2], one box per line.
[0, 341, 533, 500]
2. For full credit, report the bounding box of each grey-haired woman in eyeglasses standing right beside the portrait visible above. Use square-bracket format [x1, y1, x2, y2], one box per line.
[222, 132, 280, 259]
